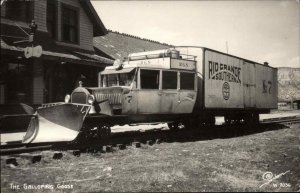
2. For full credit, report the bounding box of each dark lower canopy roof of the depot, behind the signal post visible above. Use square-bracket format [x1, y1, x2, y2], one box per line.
[1, 23, 113, 67]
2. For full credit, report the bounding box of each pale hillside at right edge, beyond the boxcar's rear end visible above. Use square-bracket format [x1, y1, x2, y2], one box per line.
[278, 67, 300, 101]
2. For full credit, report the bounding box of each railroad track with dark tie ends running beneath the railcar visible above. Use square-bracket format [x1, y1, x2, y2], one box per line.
[0, 117, 300, 165]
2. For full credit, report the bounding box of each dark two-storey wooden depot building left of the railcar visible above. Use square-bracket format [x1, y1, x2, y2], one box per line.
[0, 0, 113, 104]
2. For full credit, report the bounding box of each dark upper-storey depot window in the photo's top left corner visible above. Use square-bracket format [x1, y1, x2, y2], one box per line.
[5, 0, 34, 23]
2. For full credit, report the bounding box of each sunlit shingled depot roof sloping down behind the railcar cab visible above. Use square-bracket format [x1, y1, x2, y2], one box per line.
[94, 30, 173, 60]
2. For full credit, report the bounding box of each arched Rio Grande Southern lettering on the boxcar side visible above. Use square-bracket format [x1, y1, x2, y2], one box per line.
[208, 61, 241, 83]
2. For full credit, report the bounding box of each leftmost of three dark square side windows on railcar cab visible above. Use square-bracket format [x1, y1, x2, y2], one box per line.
[141, 69, 159, 89]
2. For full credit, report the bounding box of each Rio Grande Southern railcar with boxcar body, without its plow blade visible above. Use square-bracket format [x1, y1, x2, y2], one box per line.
[22, 47, 277, 143]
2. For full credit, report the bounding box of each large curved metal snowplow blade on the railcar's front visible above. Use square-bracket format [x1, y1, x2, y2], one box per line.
[23, 103, 90, 143]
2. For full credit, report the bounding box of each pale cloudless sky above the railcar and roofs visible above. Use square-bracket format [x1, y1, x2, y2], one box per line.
[91, 0, 300, 68]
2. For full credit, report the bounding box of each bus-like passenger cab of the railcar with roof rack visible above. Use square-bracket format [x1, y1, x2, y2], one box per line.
[97, 48, 197, 115]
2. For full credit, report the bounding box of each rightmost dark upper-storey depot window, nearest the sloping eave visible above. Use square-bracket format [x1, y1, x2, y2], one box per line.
[62, 5, 78, 43]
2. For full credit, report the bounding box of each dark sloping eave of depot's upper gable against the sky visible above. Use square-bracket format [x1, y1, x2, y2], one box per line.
[79, 0, 107, 36]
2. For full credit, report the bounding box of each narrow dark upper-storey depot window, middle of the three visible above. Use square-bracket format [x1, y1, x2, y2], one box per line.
[47, 0, 57, 39]
